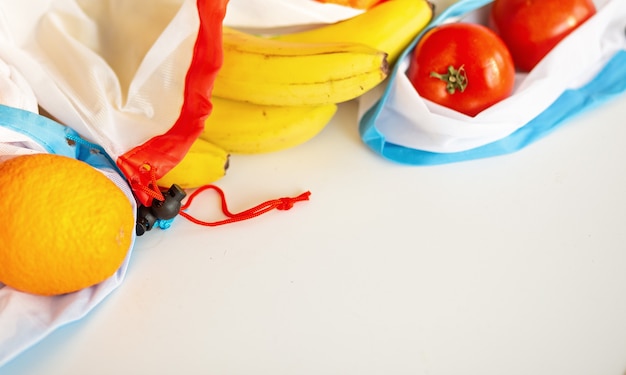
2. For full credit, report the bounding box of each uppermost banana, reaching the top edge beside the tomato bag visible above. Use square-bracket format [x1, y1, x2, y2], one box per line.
[273, 0, 434, 65]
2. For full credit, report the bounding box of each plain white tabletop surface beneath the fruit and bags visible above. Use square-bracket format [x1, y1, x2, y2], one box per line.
[0, 2, 626, 375]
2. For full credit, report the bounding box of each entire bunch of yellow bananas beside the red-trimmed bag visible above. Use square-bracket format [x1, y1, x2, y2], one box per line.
[159, 0, 433, 187]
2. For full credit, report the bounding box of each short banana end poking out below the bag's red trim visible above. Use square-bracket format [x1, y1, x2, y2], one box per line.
[157, 138, 229, 189]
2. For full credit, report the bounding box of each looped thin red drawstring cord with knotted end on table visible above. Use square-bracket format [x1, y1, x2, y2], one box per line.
[179, 185, 311, 227]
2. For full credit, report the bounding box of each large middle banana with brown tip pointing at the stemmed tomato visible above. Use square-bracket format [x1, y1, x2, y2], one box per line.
[213, 26, 388, 106]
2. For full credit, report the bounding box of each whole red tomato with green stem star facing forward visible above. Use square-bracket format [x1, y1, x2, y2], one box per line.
[407, 23, 515, 116]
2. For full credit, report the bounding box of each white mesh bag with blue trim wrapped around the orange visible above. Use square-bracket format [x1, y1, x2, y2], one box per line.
[0, 102, 136, 372]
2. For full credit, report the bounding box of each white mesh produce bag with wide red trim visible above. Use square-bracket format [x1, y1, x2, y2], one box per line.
[0, 0, 227, 205]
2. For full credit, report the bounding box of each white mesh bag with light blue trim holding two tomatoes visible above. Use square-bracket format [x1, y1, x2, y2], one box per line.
[359, 0, 626, 165]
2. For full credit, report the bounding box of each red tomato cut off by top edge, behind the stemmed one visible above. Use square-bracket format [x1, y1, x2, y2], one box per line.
[491, 0, 596, 72]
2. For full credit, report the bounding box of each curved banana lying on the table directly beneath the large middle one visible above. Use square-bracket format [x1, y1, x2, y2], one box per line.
[200, 96, 337, 154]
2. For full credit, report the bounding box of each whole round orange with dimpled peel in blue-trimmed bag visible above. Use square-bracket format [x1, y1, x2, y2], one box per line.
[0, 154, 135, 295]
